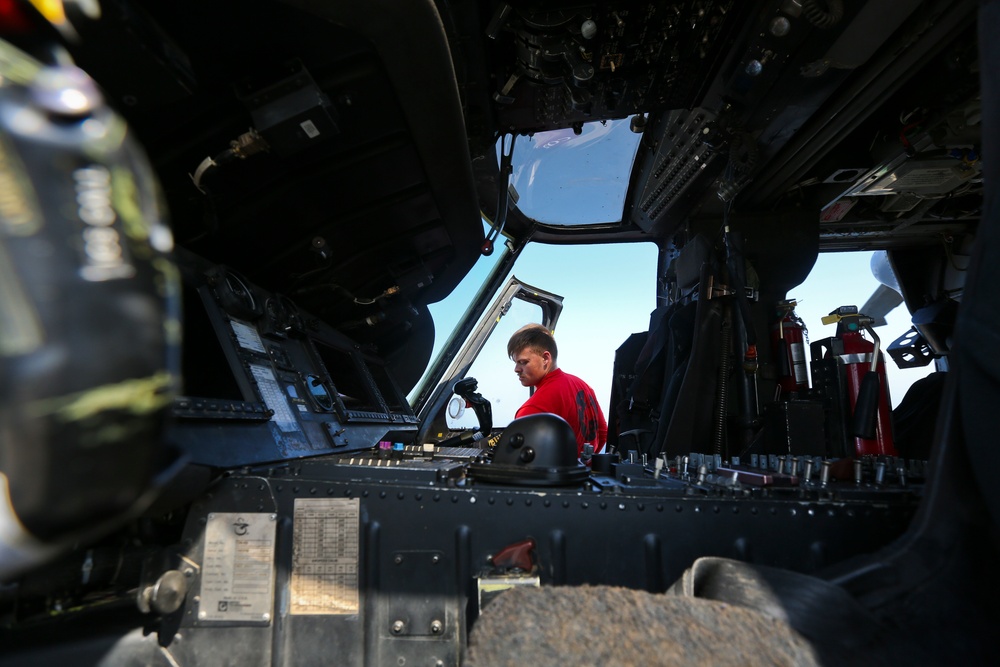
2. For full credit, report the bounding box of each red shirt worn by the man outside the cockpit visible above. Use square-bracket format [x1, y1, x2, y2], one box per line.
[514, 368, 608, 456]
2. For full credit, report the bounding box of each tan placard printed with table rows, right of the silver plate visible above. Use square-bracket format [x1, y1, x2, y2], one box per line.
[290, 498, 361, 615]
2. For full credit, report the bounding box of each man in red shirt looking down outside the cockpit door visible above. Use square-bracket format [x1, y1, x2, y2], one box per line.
[507, 324, 608, 456]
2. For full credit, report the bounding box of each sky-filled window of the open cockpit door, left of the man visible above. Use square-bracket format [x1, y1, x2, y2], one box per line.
[447, 298, 543, 430]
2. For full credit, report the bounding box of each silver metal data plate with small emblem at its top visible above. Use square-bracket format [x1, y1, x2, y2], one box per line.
[198, 512, 277, 622]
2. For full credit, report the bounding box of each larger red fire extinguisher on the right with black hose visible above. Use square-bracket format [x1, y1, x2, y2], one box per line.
[823, 306, 896, 456]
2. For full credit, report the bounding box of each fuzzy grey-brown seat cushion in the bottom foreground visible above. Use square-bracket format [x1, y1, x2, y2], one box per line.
[464, 586, 820, 667]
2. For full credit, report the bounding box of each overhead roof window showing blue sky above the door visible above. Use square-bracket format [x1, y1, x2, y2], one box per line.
[502, 118, 642, 226]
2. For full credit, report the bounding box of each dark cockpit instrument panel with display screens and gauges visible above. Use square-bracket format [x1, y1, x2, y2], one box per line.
[172, 257, 417, 467]
